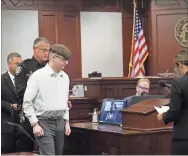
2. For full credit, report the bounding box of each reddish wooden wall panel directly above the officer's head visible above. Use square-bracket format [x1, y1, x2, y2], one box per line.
[39, 11, 59, 44]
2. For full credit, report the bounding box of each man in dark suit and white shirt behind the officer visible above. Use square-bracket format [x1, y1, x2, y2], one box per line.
[1, 53, 22, 153]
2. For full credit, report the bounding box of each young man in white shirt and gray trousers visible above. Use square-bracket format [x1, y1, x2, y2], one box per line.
[23, 44, 71, 155]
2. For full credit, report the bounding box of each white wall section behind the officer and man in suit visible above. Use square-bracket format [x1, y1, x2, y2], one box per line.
[1, 10, 39, 73]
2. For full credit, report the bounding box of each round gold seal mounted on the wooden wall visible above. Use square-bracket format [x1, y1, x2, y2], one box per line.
[174, 17, 188, 47]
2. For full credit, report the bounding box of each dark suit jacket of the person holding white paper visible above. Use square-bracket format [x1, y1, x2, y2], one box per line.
[163, 72, 188, 140]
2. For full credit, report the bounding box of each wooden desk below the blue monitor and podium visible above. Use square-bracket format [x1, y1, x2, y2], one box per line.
[64, 123, 172, 155]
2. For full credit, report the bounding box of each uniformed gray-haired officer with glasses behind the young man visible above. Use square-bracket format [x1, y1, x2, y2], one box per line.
[15, 37, 50, 152]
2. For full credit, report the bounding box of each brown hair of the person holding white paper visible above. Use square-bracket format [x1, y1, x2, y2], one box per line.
[175, 49, 188, 66]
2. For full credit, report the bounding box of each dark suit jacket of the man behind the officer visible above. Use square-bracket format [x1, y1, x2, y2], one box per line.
[1, 72, 16, 133]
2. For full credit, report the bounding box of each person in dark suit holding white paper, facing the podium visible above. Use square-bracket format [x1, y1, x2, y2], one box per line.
[158, 49, 188, 155]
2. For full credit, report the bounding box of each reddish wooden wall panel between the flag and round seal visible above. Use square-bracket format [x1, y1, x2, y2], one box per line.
[149, 8, 188, 75]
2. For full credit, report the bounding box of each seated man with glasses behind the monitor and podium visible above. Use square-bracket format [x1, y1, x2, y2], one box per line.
[125, 78, 150, 106]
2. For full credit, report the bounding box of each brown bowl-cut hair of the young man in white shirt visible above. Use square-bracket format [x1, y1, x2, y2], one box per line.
[50, 44, 71, 60]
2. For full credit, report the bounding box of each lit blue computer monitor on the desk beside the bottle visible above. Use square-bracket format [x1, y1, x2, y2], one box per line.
[99, 99, 127, 125]
